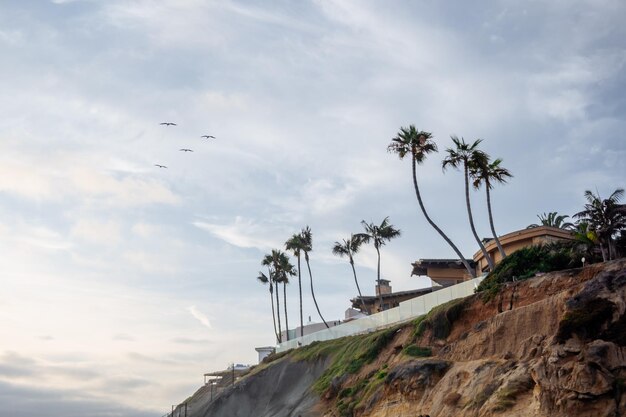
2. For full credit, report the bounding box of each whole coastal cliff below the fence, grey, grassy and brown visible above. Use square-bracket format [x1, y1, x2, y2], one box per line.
[175, 259, 626, 417]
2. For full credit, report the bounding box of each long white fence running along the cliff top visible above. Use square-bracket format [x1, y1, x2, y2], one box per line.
[276, 277, 483, 352]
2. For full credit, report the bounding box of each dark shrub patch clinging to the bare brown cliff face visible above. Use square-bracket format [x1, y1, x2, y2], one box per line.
[556, 298, 615, 342]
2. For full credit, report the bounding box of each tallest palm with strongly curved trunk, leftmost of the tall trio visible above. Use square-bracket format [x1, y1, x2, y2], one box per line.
[387, 125, 476, 277]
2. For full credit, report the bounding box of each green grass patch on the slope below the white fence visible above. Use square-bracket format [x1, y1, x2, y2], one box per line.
[292, 326, 402, 394]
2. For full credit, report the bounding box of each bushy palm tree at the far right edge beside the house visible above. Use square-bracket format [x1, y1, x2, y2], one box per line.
[574, 188, 626, 261]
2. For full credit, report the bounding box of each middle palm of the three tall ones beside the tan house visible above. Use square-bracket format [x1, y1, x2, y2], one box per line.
[441, 136, 495, 271]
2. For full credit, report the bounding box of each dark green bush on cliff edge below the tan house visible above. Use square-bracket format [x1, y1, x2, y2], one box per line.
[477, 243, 571, 301]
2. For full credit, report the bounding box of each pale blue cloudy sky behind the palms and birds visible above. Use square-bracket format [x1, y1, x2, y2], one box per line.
[0, 0, 626, 417]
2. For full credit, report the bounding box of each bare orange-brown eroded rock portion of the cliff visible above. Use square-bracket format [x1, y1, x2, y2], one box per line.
[342, 260, 626, 417]
